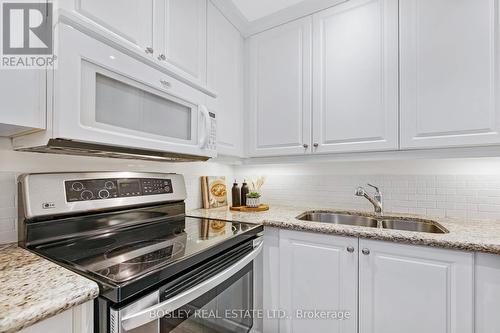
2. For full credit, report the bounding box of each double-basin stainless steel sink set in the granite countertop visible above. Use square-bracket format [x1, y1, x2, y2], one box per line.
[297, 212, 449, 234]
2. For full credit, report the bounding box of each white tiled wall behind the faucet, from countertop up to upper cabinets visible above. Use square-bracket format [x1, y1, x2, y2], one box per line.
[236, 158, 500, 220]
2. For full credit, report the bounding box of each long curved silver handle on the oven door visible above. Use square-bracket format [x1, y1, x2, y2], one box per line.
[121, 242, 263, 331]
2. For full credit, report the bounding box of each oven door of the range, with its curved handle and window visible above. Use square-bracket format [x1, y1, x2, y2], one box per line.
[109, 238, 262, 333]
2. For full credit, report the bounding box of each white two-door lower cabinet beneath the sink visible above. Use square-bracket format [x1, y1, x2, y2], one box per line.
[263, 229, 474, 333]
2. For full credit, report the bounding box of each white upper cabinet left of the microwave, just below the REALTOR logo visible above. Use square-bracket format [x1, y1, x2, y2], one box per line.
[0, 69, 47, 136]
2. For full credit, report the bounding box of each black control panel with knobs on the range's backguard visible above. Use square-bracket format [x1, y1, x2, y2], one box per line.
[64, 178, 173, 202]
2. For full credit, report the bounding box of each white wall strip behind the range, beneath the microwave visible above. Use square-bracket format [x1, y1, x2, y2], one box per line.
[0, 138, 233, 243]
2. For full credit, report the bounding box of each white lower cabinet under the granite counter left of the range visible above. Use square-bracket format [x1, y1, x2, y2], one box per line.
[19, 301, 94, 333]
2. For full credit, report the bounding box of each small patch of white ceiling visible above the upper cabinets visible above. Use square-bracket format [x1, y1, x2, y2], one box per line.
[232, 0, 308, 22]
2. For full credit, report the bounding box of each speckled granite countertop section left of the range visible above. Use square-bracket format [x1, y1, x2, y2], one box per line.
[0, 244, 99, 333]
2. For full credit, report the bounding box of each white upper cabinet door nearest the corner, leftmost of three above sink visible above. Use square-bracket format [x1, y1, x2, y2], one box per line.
[248, 17, 312, 156]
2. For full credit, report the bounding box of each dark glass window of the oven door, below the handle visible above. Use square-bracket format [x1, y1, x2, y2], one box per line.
[160, 264, 253, 333]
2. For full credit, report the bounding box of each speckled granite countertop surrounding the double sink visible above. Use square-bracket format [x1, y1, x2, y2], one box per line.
[188, 207, 500, 254]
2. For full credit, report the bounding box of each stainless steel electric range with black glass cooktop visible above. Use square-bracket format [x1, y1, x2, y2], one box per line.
[19, 172, 263, 333]
